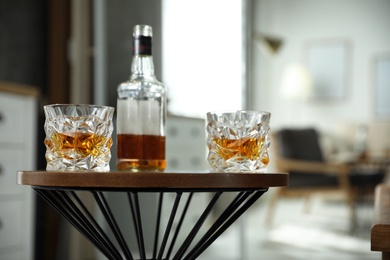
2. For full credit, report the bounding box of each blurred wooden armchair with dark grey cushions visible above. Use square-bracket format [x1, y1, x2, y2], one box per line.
[266, 128, 355, 224]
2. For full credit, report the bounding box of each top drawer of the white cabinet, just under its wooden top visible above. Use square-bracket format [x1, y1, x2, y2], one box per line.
[0, 94, 26, 143]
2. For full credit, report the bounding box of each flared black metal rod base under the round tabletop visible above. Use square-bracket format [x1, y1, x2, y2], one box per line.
[34, 187, 268, 260]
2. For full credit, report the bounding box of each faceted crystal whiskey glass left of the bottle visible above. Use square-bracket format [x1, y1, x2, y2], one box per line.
[44, 105, 114, 171]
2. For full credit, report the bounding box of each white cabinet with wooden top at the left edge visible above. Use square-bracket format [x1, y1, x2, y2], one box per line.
[0, 86, 37, 260]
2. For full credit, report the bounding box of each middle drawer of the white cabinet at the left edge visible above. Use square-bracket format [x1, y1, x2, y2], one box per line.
[0, 149, 27, 196]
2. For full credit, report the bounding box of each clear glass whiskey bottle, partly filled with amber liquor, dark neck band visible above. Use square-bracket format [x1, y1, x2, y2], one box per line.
[117, 25, 167, 172]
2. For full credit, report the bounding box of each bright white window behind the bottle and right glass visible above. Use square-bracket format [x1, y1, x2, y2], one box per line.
[162, 0, 244, 118]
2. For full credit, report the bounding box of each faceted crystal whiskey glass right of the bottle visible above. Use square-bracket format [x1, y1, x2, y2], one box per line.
[206, 111, 271, 172]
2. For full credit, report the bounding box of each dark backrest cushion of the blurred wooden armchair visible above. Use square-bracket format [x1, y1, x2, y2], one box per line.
[277, 128, 324, 162]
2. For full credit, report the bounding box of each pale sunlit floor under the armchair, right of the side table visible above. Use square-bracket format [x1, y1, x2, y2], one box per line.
[198, 190, 381, 260]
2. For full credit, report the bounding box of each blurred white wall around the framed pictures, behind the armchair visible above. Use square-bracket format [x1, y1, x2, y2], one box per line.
[252, 0, 390, 135]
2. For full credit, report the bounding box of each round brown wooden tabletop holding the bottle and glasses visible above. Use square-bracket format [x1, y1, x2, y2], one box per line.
[17, 171, 288, 189]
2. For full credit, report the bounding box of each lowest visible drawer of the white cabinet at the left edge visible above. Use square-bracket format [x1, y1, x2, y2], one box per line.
[0, 201, 23, 248]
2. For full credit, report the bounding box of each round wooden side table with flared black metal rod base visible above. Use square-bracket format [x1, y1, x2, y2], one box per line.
[17, 171, 288, 260]
